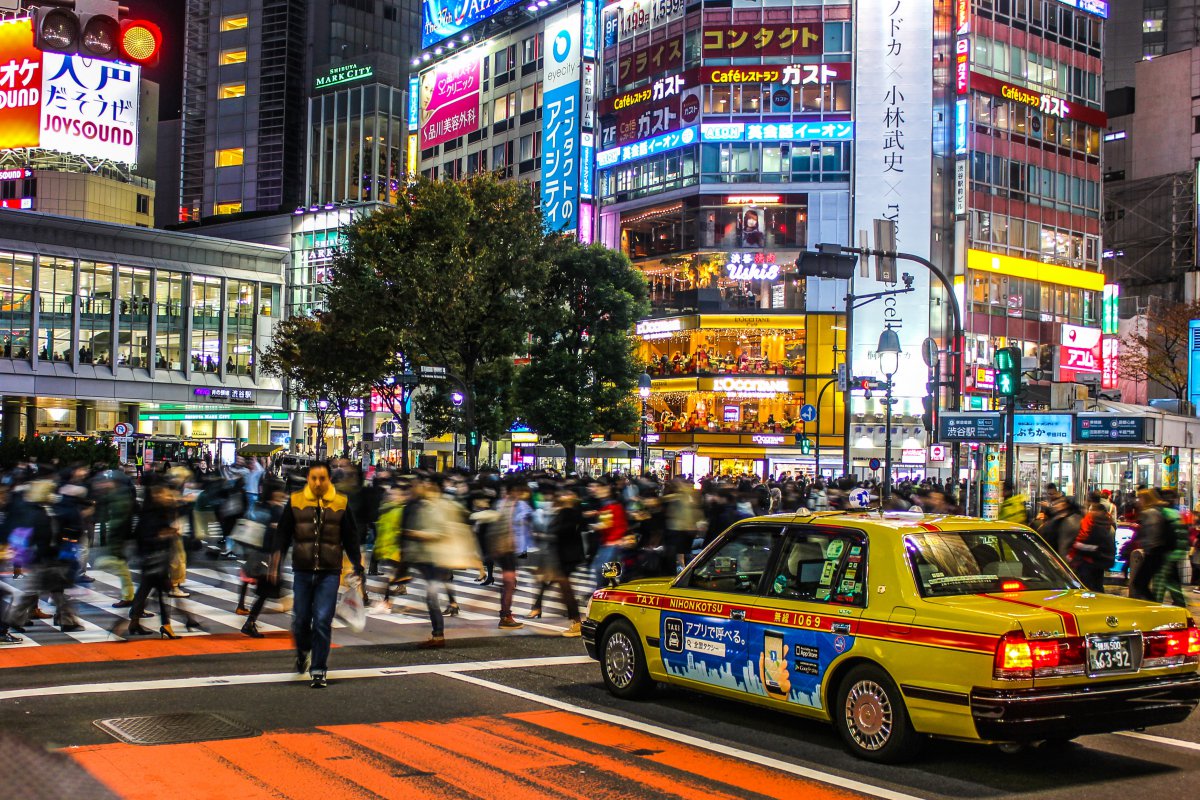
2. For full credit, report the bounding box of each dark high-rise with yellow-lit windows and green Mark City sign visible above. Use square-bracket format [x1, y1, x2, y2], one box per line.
[179, 0, 419, 222]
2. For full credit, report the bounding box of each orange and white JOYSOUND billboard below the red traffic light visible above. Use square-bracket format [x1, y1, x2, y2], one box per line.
[0, 18, 142, 164]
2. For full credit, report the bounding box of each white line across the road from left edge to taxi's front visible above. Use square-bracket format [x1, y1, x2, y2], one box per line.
[0, 657, 592, 700]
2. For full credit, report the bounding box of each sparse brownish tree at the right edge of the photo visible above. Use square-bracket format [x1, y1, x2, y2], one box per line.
[1117, 302, 1200, 404]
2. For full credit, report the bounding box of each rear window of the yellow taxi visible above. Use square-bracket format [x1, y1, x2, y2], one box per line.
[905, 530, 1082, 597]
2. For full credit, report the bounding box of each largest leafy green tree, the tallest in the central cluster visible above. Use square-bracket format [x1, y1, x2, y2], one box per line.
[328, 174, 547, 468]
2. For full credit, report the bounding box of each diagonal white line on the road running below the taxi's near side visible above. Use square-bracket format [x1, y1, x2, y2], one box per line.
[445, 672, 922, 800]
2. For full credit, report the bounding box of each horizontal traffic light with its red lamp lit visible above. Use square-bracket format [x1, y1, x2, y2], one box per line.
[30, 0, 162, 67]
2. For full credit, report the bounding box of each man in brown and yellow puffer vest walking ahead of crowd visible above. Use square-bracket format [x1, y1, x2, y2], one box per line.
[271, 464, 364, 688]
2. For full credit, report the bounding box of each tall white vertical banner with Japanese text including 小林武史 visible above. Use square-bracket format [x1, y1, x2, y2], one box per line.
[847, 0, 934, 398]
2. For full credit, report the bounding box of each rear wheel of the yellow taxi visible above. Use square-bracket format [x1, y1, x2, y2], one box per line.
[833, 664, 924, 764]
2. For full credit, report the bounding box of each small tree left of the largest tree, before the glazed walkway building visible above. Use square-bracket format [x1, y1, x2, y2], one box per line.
[259, 312, 370, 457]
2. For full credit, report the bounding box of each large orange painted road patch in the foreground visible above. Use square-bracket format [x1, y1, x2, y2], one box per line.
[66, 711, 864, 800]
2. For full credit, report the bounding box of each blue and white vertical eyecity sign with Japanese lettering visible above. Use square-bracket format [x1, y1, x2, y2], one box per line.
[541, 6, 582, 231]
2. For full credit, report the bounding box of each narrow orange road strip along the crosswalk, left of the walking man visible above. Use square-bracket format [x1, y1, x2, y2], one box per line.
[0, 632, 297, 669]
